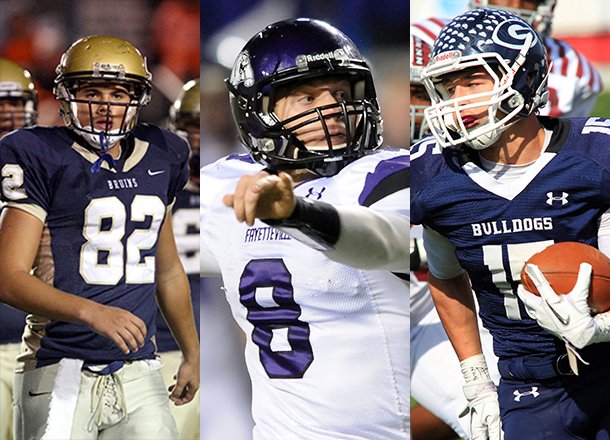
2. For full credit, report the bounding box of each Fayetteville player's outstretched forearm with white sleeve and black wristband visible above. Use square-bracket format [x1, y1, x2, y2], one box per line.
[266, 198, 409, 273]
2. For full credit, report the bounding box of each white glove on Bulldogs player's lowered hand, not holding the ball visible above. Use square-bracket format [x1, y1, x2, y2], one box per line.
[460, 354, 504, 440]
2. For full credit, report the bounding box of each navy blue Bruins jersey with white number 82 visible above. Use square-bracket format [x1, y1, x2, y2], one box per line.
[0, 124, 189, 366]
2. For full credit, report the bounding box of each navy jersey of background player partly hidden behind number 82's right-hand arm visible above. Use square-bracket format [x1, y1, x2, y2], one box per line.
[157, 183, 201, 353]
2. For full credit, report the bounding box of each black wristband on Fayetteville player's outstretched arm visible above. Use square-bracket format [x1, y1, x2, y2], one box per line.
[263, 197, 341, 250]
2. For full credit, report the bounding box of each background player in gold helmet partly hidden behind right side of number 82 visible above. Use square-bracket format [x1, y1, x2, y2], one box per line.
[156, 79, 201, 440]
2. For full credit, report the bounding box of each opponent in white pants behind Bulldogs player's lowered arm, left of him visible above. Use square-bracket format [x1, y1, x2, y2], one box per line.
[409, 35, 499, 440]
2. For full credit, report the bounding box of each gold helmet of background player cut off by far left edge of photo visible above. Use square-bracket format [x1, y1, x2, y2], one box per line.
[0, 58, 38, 137]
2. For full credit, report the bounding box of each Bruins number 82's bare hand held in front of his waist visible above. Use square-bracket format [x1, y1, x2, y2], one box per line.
[84, 303, 146, 354]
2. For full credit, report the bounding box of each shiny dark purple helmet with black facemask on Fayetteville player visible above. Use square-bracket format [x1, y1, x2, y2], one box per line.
[226, 18, 382, 176]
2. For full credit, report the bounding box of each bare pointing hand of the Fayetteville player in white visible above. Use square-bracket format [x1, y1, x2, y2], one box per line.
[223, 171, 296, 226]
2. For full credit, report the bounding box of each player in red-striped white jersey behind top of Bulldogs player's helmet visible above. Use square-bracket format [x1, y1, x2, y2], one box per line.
[411, 0, 603, 118]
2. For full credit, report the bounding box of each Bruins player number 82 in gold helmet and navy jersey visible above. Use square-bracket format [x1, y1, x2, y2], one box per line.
[0, 36, 199, 439]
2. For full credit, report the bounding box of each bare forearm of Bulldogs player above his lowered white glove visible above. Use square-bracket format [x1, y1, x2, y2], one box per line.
[428, 273, 482, 361]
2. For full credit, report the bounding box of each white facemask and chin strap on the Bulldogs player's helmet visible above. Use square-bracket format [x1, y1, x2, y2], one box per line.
[422, 34, 532, 150]
